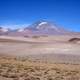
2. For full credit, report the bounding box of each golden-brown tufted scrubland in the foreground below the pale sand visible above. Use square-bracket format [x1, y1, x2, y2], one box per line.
[0, 57, 80, 80]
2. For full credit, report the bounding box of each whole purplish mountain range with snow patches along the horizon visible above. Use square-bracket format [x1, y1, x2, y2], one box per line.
[0, 20, 77, 36]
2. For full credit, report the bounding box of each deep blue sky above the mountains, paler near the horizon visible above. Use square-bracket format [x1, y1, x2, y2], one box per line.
[0, 0, 80, 31]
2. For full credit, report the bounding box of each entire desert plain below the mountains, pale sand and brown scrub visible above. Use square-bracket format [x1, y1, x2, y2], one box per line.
[0, 35, 80, 80]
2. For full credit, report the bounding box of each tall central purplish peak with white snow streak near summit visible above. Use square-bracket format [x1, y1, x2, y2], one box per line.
[24, 20, 68, 35]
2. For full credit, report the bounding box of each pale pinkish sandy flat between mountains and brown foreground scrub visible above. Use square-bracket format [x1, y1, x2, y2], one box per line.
[0, 35, 80, 64]
